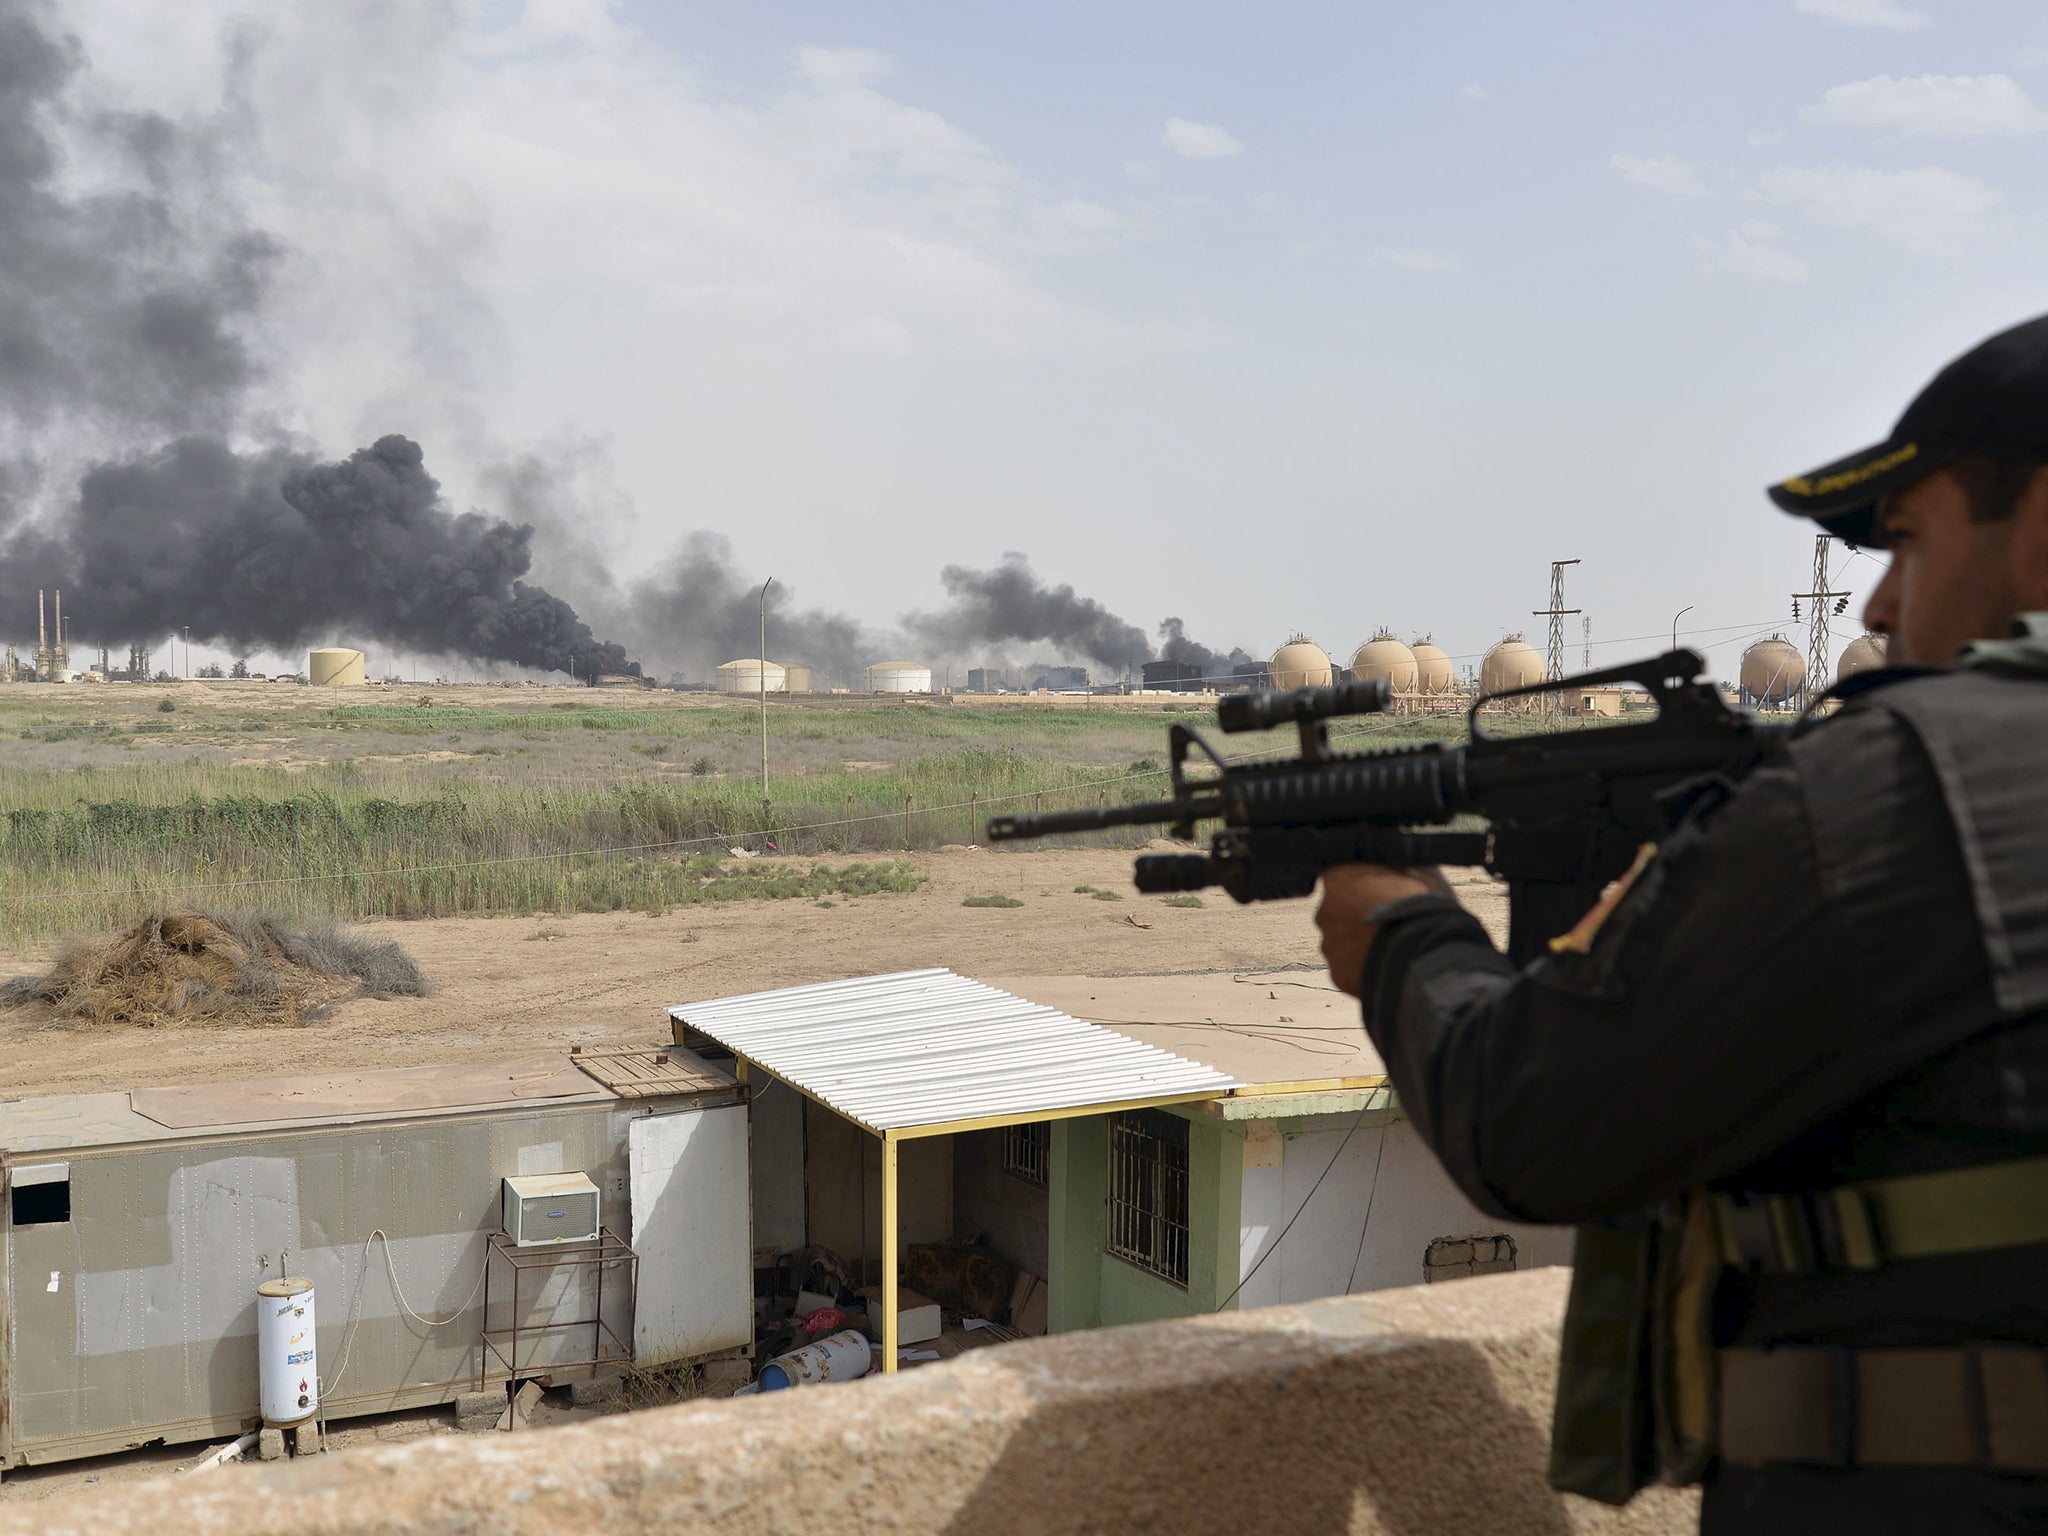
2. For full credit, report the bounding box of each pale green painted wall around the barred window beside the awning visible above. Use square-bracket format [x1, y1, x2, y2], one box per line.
[1047, 1114, 1245, 1333]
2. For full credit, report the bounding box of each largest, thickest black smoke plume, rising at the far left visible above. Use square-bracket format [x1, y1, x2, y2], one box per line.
[0, 0, 637, 676]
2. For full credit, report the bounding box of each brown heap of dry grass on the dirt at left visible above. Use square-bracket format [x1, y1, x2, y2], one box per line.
[0, 911, 428, 1028]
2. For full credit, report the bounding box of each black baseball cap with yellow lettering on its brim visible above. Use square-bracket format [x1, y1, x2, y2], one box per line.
[1769, 315, 2048, 547]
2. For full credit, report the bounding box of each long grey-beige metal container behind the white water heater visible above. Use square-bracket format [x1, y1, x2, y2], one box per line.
[0, 1047, 752, 1470]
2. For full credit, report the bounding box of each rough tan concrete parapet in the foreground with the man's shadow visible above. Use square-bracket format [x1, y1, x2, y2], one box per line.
[0, 1270, 1698, 1536]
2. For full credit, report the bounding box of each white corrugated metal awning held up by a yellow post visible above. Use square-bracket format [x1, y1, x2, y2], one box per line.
[668, 969, 1239, 1133]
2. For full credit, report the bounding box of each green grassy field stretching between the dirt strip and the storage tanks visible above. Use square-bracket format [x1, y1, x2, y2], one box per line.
[0, 684, 1540, 940]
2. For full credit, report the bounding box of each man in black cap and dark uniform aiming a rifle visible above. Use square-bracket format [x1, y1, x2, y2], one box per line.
[1317, 317, 2048, 1536]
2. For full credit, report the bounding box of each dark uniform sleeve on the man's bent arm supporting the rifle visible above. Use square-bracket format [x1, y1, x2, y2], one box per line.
[1364, 707, 1987, 1221]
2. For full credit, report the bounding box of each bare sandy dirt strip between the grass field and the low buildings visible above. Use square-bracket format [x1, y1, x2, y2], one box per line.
[0, 848, 1505, 1098]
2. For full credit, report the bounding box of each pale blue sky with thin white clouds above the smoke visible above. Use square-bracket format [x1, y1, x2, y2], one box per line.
[56, 0, 2048, 674]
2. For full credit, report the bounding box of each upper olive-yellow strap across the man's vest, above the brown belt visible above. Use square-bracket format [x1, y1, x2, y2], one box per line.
[1716, 1157, 2048, 1274]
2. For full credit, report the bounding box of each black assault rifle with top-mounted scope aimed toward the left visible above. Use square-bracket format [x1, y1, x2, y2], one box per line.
[987, 651, 1786, 963]
